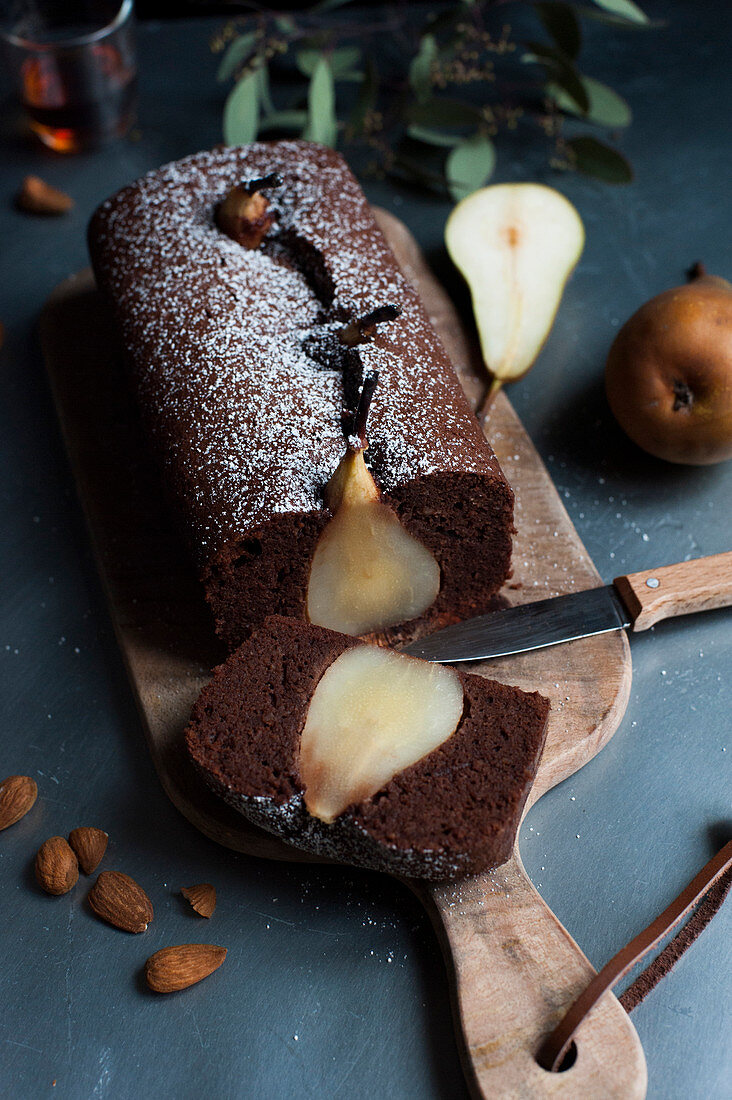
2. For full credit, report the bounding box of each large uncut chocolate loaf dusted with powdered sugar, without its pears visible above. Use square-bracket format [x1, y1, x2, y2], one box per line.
[89, 141, 513, 647]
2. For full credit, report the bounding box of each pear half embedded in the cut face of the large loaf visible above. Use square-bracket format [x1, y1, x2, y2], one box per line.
[307, 446, 440, 635]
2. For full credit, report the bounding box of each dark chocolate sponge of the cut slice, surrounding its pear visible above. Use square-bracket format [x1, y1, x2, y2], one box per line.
[186, 616, 549, 879]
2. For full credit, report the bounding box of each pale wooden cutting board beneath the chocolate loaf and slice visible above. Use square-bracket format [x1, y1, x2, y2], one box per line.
[41, 210, 646, 1100]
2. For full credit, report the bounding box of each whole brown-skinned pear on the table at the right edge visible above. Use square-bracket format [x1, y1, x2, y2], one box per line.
[605, 275, 732, 465]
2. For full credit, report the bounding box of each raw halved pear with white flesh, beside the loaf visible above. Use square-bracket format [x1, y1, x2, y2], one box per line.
[445, 184, 584, 409]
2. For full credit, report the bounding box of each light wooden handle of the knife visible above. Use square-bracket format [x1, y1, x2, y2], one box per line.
[613, 551, 732, 630]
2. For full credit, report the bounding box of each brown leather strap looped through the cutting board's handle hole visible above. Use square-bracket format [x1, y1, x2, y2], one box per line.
[536, 840, 732, 1071]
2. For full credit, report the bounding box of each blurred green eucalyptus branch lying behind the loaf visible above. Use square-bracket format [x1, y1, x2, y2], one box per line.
[214, 0, 648, 193]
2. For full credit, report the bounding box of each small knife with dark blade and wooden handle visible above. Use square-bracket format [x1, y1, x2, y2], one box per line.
[401, 551, 732, 664]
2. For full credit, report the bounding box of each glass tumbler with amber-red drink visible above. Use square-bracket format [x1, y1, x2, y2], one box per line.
[0, 0, 136, 153]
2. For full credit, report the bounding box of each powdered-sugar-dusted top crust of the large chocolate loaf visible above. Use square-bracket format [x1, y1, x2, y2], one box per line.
[92, 142, 489, 552]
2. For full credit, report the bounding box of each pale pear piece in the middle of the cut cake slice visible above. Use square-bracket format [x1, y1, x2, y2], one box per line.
[299, 646, 463, 823]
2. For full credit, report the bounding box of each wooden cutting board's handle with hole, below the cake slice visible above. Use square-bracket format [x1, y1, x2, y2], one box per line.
[420, 854, 646, 1100]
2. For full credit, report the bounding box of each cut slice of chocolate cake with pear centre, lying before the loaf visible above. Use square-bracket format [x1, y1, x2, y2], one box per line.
[186, 616, 549, 879]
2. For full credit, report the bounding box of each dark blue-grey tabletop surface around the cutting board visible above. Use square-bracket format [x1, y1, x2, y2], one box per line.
[0, 8, 732, 1100]
